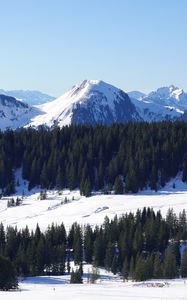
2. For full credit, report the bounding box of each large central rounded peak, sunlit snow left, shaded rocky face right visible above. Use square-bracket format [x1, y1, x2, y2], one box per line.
[29, 80, 141, 127]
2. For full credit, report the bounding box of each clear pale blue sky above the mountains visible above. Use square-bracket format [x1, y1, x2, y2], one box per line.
[0, 0, 187, 96]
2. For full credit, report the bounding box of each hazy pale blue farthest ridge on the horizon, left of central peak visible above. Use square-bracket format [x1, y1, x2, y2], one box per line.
[0, 89, 55, 105]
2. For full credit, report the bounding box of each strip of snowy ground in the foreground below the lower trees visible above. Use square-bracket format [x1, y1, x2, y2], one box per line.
[0, 272, 187, 300]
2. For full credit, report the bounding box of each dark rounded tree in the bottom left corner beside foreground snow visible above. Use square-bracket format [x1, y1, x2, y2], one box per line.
[0, 256, 18, 291]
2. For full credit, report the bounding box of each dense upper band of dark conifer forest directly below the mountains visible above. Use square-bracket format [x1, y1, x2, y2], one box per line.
[0, 122, 187, 196]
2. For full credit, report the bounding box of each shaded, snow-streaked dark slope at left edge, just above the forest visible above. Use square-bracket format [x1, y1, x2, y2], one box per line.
[0, 95, 41, 130]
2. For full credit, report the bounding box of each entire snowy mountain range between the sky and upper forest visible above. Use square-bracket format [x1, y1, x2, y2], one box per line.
[0, 80, 187, 130]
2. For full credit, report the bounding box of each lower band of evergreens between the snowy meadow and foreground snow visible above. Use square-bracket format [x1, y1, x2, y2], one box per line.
[0, 208, 187, 287]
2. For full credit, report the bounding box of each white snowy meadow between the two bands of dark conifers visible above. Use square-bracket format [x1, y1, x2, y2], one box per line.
[0, 174, 187, 230]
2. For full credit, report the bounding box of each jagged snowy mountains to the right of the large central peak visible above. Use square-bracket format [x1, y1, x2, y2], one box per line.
[128, 85, 187, 122]
